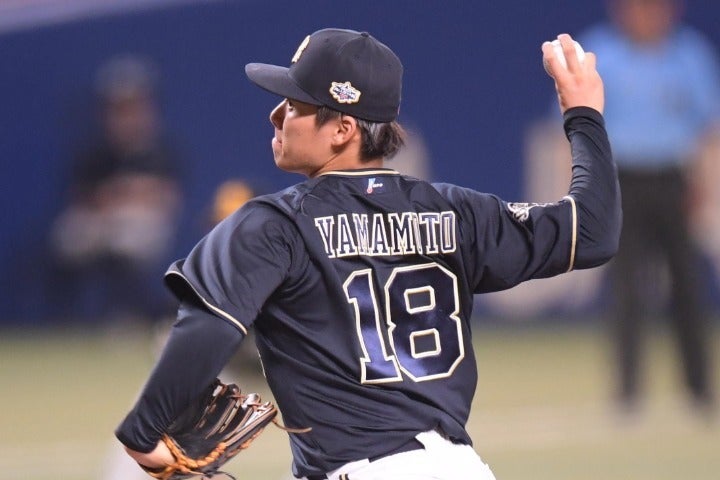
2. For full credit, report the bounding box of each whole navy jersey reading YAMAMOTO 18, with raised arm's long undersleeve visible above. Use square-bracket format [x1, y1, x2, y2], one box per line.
[119, 108, 620, 476]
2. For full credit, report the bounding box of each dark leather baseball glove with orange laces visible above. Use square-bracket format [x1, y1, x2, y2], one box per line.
[141, 379, 278, 480]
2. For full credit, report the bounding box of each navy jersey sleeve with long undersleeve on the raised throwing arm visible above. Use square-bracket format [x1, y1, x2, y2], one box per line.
[436, 107, 622, 293]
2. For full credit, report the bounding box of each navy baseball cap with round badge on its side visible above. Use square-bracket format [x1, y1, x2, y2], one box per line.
[245, 28, 403, 123]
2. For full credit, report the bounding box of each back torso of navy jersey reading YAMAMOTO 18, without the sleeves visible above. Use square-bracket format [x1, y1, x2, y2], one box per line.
[255, 171, 477, 473]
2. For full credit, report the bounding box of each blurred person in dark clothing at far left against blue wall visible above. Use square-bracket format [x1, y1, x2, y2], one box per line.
[49, 56, 182, 323]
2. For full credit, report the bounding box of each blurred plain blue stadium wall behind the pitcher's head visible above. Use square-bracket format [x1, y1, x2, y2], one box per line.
[0, 0, 720, 322]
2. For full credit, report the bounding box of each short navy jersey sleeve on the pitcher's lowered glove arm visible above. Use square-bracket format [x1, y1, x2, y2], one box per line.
[165, 201, 298, 334]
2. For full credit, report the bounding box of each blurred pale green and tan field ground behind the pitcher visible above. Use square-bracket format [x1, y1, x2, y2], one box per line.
[0, 326, 720, 480]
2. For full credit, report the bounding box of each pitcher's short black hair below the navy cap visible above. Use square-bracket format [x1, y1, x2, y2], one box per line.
[316, 105, 406, 160]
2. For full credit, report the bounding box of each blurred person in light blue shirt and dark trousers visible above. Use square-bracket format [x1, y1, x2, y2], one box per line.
[579, 0, 720, 412]
